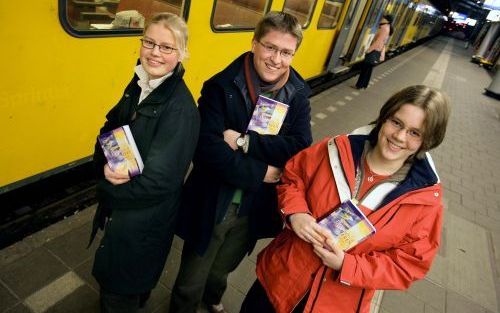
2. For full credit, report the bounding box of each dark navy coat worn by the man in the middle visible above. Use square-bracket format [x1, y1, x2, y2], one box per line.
[178, 54, 312, 255]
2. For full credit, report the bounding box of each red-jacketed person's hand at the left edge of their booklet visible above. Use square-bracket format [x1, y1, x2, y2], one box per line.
[289, 213, 330, 246]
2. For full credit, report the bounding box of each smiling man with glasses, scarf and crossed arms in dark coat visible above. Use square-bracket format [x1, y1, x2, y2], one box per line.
[170, 12, 312, 313]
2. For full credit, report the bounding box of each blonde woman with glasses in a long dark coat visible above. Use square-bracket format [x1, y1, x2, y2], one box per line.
[92, 13, 200, 312]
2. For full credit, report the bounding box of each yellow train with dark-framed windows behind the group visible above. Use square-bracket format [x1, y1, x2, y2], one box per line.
[0, 0, 443, 194]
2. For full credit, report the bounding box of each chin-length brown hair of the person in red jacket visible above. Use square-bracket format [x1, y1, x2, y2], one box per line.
[372, 85, 451, 155]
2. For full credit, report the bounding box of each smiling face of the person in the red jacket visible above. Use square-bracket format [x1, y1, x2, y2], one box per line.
[373, 104, 425, 168]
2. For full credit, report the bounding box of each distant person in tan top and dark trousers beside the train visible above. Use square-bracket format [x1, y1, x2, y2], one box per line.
[355, 14, 394, 89]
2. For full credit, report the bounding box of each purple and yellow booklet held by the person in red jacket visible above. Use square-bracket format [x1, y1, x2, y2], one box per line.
[319, 200, 376, 251]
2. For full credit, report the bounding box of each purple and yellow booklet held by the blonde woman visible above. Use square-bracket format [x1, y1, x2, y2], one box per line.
[98, 125, 144, 177]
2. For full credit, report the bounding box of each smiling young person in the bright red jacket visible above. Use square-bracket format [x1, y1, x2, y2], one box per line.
[242, 86, 450, 313]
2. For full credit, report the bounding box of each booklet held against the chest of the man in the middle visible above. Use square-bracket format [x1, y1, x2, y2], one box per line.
[247, 95, 288, 135]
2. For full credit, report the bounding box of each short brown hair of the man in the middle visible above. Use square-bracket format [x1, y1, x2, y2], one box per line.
[253, 11, 303, 49]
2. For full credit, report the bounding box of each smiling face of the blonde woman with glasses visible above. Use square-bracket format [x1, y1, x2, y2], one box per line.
[140, 24, 180, 79]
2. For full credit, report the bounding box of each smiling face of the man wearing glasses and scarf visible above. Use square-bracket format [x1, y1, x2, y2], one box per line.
[252, 30, 297, 83]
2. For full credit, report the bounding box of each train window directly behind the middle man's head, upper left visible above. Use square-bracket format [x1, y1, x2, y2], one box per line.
[212, 0, 271, 31]
